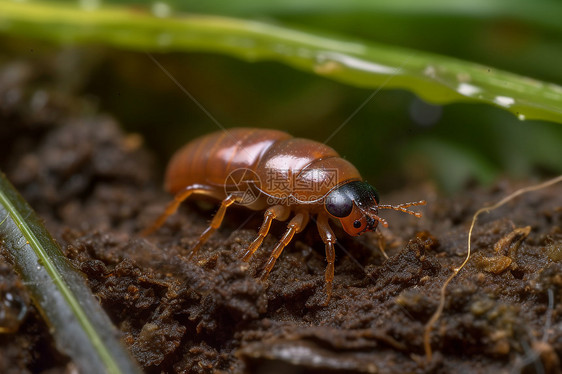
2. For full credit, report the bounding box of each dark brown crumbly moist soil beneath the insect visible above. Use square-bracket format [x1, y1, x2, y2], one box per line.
[0, 59, 562, 373]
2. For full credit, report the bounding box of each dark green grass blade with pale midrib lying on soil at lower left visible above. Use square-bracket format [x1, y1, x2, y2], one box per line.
[0, 173, 140, 374]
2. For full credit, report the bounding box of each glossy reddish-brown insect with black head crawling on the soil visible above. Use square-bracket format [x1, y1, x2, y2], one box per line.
[143, 128, 425, 300]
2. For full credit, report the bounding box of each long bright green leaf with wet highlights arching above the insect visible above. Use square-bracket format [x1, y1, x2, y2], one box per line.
[0, 0, 562, 122]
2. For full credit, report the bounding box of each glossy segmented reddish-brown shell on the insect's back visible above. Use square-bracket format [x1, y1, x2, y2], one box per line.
[165, 128, 361, 209]
